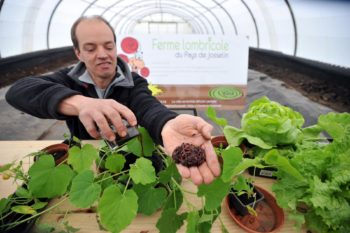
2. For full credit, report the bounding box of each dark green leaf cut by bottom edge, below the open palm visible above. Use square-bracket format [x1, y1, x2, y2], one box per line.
[156, 209, 186, 233]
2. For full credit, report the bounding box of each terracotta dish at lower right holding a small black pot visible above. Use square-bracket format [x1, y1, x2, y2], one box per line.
[226, 186, 284, 233]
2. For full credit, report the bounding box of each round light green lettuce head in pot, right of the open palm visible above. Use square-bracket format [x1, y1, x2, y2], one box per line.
[207, 96, 319, 178]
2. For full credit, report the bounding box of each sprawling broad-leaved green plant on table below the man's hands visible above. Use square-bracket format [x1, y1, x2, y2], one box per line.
[0, 128, 235, 232]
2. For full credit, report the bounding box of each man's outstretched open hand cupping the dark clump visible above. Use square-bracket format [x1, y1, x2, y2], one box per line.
[162, 114, 220, 185]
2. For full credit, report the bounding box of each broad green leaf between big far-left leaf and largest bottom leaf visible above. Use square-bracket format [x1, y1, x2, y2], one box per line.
[69, 170, 101, 208]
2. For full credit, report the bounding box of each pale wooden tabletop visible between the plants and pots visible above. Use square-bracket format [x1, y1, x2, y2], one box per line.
[0, 141, 306, 233]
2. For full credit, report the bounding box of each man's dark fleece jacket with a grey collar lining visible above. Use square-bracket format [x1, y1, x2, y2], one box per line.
[6, 58, 177, 144]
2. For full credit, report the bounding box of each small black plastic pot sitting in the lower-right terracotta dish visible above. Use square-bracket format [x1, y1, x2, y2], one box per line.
[228, 187, 264, 216]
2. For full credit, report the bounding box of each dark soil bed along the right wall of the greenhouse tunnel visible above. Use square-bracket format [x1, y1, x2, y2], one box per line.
[249, 56, 350, 112]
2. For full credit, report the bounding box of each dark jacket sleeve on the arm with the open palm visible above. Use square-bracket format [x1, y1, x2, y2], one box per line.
[130, 73, 178, 145]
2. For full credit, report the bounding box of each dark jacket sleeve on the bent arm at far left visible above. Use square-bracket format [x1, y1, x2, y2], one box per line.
[5, 68, 79, 120]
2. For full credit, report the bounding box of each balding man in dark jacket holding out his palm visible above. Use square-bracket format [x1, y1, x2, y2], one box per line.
[6, 16, 220, 185]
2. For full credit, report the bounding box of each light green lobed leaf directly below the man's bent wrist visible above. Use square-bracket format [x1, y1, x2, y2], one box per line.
[68, 144, 98, 173]
